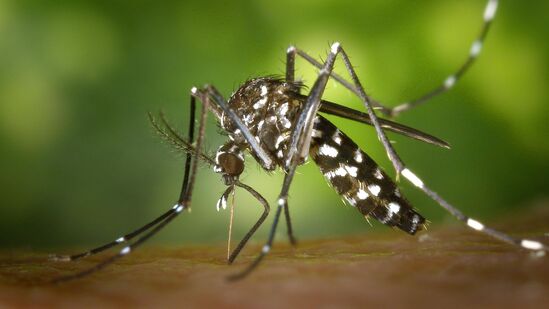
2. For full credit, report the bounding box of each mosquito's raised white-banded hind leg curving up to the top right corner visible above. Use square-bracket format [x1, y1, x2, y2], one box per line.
[286, 0, 498, 117]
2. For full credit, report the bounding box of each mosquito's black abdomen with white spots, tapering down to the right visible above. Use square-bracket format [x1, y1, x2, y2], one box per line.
[310, 115, 425, 234]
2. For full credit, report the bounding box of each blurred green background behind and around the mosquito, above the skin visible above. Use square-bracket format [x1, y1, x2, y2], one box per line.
[0, 0, 549, 248]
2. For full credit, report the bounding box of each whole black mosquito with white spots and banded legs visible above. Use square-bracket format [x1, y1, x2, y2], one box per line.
[49, 0, 548, 282]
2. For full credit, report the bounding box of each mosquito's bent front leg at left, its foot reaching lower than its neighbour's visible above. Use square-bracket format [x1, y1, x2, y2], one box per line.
[52, 88, 209, 283]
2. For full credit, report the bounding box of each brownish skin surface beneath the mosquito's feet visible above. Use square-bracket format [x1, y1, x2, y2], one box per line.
[0, 203, 549, 308]
